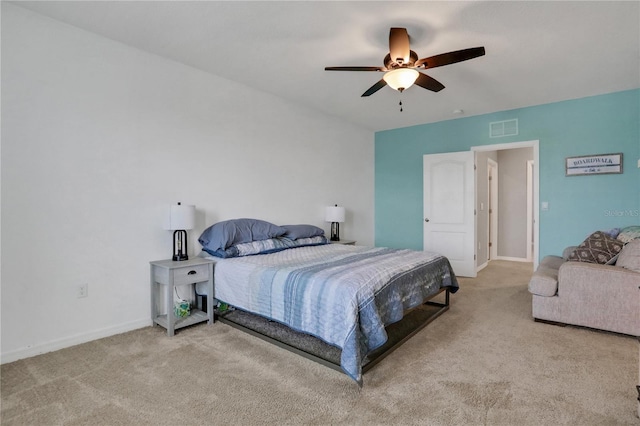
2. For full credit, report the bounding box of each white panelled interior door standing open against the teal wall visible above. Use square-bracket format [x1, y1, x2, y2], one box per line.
[423, 151, 476, 277]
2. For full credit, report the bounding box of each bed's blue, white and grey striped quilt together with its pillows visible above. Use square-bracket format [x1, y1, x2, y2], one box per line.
[196, 219, 458, 386]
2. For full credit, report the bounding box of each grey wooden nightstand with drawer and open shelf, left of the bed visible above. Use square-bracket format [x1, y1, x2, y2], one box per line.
[149, 258, 214, 336]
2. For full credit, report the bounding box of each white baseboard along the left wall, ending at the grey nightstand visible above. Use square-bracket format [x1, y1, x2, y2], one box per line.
[0, 319, 152, 364]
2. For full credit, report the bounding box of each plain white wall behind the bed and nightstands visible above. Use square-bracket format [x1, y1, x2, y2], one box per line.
[1, 2, 374, 362]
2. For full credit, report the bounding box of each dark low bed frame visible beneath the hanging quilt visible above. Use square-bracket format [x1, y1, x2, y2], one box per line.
[215, 287, 449, 374]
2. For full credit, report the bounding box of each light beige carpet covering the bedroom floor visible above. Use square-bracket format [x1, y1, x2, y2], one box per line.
[0, 261, 640, 425]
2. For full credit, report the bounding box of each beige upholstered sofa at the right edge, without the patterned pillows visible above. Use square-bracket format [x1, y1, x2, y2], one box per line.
[529, 239, 640, 336]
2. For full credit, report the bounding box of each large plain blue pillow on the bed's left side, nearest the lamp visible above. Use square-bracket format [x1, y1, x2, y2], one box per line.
[198, 219, 286, 253]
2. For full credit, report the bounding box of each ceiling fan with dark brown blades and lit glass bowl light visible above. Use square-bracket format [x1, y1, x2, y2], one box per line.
[325, 28, 485, 96]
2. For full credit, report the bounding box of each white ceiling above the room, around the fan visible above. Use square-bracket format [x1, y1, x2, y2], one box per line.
[10, 1, 640, 131]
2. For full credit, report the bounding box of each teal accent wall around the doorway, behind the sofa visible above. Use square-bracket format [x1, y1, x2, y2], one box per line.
[375, 89, 640, 259]
